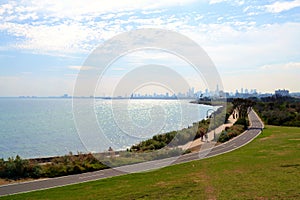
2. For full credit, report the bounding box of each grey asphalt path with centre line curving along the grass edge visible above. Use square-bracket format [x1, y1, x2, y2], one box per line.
[0, 111, 263, 196]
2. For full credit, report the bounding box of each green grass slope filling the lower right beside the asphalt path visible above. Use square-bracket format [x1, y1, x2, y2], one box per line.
[1, 126, 300, 200]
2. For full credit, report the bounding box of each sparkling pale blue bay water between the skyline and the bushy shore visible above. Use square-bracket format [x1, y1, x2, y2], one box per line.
[0, 98, 212, 158]
